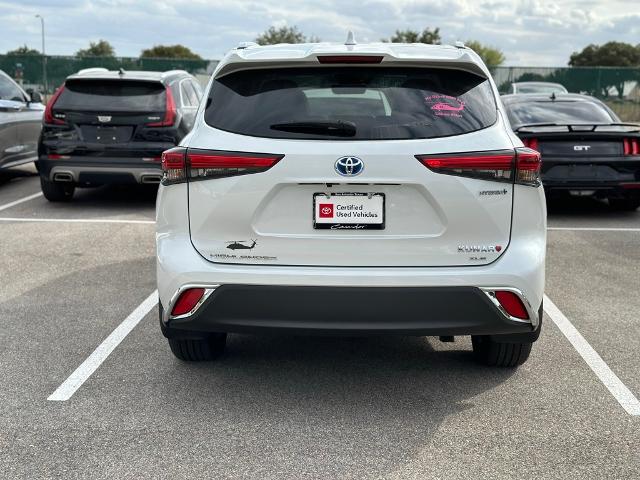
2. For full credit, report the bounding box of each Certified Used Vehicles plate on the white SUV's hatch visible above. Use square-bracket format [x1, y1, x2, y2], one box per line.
[313, 193, 384, 230]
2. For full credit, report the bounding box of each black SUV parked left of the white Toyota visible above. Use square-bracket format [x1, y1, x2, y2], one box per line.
[36, 68, 202, 201]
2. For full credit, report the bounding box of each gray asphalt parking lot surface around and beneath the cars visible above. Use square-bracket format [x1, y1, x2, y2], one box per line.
[0, 164, 640, 479]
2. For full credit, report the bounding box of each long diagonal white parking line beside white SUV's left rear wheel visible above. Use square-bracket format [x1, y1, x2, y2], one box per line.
[47, 290, 158, 402]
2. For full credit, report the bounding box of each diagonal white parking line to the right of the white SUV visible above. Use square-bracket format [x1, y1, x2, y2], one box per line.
[544, 295, 640, 416]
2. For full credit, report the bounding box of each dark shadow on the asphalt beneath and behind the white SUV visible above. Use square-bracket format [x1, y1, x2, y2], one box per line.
[148, 335, 515, 478]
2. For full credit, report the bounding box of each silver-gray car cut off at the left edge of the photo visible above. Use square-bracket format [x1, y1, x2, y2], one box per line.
[0, 70, 44, 170]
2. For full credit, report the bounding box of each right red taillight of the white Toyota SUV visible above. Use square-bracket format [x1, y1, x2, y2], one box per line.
[416, 148, 540, 186]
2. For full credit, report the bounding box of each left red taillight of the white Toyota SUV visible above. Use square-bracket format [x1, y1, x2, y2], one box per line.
[162, 147, 283, 185]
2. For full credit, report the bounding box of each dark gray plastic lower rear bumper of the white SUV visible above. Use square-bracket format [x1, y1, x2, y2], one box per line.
[161, 285, 539, 340]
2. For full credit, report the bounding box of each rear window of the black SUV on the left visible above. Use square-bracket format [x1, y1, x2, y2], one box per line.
[55, 80, 166, 112]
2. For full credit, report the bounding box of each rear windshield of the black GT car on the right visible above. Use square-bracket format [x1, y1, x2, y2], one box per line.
[505, 100, 614, 126]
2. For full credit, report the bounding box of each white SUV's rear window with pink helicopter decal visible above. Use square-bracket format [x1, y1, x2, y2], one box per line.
[205, 67, 497, 140]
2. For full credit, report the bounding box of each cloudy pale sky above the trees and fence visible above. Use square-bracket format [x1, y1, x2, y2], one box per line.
[0, 0, 640, 66]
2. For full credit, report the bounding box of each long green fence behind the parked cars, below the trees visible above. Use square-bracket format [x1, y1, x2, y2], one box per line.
[0, 55, 640, 122]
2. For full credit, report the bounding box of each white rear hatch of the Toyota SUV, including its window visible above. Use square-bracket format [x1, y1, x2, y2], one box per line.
[188, 62, 513, 267]
